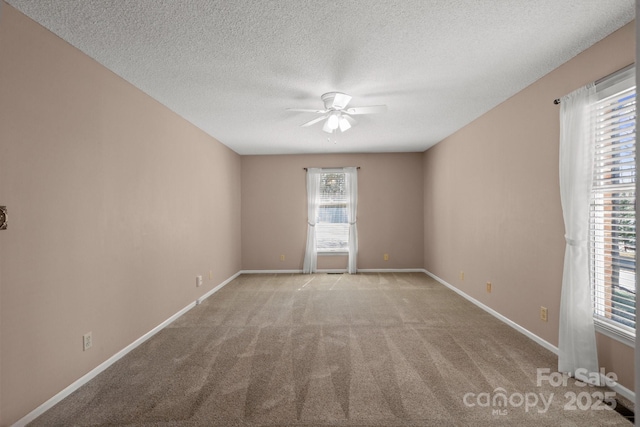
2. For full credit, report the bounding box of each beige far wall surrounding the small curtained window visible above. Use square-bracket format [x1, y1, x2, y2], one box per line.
[242, 154, 423, 270]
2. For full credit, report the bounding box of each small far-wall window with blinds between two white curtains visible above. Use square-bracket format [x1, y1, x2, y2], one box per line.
[316, 172, 349, 252]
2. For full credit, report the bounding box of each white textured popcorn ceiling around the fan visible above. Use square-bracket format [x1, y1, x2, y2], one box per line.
[7, 0, 635, 154]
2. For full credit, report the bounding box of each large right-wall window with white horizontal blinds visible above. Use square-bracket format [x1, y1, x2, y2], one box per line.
[590, 68, 636, 341]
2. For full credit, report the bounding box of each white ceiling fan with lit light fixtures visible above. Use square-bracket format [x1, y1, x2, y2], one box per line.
[287, 92, 387, 133]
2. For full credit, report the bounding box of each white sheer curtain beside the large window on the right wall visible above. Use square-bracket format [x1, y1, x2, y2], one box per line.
[558, 83, 599, 383]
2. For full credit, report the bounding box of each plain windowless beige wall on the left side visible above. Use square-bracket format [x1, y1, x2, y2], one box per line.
[0, 4, 241, 426]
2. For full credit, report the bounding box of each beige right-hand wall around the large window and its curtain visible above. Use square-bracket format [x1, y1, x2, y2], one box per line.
[424, 23, 635, 390]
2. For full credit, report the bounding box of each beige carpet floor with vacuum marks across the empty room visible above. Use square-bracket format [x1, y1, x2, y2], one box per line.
[32, 273, 631, 427]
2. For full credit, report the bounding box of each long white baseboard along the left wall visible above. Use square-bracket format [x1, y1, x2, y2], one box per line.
[11, 272, 241, 427]
